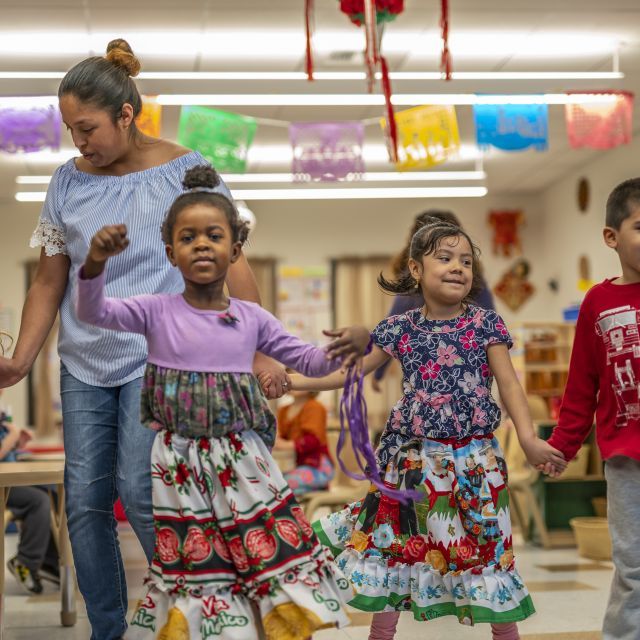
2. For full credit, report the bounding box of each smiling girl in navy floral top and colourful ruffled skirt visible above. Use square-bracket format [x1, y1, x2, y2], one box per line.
[292, 223, 566, 640]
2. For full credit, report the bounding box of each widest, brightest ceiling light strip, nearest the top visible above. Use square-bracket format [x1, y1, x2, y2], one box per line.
[0, 27, 620, 59]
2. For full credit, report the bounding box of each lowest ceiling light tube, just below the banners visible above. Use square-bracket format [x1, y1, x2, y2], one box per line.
[15, 187, 487, 202]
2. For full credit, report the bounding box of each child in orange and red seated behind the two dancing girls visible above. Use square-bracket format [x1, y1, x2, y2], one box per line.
[275, 384, 334, 496]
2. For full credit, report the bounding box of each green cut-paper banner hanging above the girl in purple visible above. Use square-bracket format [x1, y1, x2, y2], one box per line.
[178, 107, 257, 173]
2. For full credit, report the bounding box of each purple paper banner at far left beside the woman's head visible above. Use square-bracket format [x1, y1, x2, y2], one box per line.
[0, 104, 62, 153]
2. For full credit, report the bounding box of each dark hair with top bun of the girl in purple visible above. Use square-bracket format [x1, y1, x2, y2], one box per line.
[162, 165, 249, 245]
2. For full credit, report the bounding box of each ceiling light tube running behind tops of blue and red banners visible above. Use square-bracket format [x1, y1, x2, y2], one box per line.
[158, 93, 616, 107]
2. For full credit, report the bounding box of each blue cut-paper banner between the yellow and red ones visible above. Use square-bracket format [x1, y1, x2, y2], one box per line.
[473, 104, 549, 151]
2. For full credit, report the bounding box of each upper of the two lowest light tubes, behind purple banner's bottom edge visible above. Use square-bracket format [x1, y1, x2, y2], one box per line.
[16, 171, 487, 184]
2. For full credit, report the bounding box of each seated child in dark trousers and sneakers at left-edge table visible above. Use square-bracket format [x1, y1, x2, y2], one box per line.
[0, 411, 60, 594]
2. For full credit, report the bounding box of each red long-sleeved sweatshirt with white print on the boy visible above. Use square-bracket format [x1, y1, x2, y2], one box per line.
[549, 278, 640, 460]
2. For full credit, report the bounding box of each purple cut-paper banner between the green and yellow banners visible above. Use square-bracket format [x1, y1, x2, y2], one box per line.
[289, 122, 364, 182]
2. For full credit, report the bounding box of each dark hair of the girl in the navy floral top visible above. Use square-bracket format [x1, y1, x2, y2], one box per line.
[378, 218, 481, 303]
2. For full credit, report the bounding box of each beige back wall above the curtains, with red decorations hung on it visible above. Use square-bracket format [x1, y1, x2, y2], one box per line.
[242, 194, 546, 322]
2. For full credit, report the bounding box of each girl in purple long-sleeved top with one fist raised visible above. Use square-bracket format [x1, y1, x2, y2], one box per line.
[77, 166, 369, 640]
